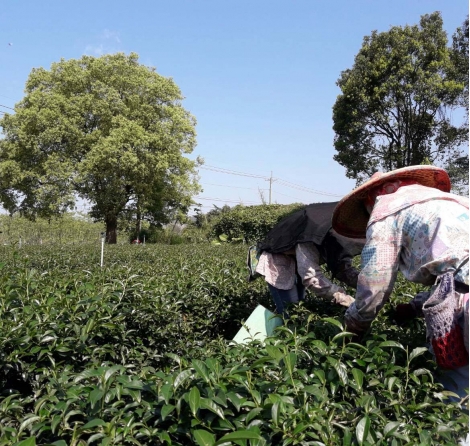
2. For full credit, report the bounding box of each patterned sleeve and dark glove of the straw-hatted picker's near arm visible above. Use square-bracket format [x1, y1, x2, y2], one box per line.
[345, 216, 401, 332]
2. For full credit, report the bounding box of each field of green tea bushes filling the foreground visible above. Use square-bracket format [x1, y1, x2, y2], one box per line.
[0, 244, 468, 446]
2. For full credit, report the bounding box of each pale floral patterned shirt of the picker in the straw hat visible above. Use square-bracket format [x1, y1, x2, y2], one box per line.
[345, 185, 469, 331]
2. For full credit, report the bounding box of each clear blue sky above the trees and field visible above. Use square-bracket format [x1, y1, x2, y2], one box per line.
[0, 0, 468, 212]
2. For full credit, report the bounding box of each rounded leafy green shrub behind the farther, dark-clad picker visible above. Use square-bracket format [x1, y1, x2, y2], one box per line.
[212, 203, 305, 243]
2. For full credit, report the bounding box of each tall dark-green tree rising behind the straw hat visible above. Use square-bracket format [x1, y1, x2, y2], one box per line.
[333, 12, 468, 183]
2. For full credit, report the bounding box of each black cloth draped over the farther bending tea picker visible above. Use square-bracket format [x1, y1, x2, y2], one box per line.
[257, 201, 365, 277]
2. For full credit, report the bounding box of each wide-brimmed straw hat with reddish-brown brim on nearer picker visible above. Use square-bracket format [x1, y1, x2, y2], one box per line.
[332, 166, 450, 238]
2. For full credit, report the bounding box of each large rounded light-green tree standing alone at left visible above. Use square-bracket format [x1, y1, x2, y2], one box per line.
[0, 53, 199, 243]
